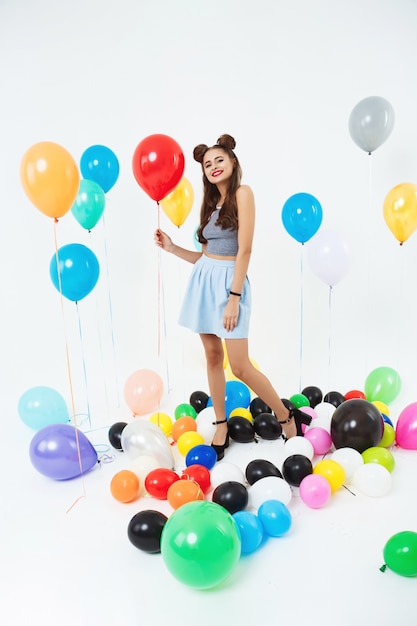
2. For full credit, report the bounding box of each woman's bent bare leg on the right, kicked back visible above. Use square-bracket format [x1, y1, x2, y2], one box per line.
[226, 339, 297, 439]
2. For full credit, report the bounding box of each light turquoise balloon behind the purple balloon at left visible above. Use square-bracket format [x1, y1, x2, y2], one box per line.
[18, 387, 70, 430]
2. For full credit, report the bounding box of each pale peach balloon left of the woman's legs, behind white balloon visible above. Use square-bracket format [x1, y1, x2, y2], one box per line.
[124, 369, 164, 415]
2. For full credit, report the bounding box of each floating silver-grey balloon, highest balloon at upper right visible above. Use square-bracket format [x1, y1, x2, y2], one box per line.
[349, 96, 395, 154]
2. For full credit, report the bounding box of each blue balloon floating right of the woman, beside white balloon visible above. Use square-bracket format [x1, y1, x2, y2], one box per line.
[281, 193, 323, 244]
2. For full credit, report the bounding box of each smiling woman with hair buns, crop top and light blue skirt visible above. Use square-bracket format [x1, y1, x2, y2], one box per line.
[155, 135, 311, 460]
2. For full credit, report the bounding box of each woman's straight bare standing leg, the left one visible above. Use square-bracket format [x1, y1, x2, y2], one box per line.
[200, 334, 227, 446]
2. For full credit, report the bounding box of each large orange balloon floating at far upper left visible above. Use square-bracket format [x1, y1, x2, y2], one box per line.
[20, 141, 80, 219]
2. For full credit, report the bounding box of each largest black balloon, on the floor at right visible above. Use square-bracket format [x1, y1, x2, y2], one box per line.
[330, 398, 384, 453]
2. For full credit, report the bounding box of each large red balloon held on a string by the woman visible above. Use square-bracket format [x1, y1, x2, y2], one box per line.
[132, 134, 185, 202]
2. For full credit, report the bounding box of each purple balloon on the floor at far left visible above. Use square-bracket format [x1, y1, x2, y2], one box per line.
[29, 424, 97, 480]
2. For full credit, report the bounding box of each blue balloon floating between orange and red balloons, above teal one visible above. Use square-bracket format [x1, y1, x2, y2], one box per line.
[80, 145, 120, 193]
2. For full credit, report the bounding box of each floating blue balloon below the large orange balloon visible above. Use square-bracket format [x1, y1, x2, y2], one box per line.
[49, 243, 100, 302]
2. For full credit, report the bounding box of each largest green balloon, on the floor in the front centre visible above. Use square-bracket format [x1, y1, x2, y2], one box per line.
[161, 500, 241, 589]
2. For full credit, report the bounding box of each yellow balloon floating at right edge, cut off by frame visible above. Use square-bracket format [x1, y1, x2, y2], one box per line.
[384, 183, 417, 245]
